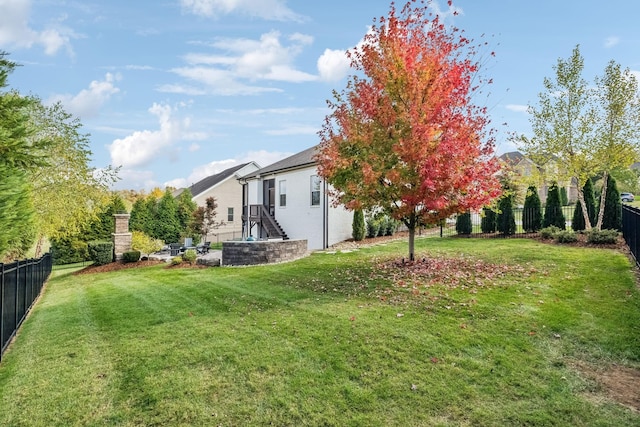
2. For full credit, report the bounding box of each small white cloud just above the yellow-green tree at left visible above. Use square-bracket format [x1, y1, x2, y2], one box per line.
[49, 73, 120, 119]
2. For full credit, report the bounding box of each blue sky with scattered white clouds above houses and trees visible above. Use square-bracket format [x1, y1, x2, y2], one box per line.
[0, 0, 640, 190]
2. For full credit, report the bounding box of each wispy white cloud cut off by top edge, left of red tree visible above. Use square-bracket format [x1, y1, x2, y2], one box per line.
[180, 0, 305, 22]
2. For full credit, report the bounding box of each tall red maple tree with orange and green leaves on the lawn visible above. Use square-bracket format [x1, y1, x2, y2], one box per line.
[316, 0, 500, 260]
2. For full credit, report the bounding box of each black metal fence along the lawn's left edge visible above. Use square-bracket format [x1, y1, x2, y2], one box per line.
[0, 254, 52, 360]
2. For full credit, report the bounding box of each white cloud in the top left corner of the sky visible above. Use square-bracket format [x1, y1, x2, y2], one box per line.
[0, 0, 78, 55]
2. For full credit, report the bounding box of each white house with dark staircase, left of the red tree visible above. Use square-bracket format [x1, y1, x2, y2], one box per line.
[240, 147, 353, 250]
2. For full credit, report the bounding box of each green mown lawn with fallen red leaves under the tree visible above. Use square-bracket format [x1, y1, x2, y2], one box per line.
[0, 238, 640, 426]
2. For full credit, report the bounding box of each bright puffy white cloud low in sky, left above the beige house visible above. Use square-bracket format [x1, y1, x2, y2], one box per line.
[108, 103, 189, 169]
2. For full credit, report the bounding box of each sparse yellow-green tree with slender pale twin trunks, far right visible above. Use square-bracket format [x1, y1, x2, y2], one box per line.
[515, 46, 640, 230]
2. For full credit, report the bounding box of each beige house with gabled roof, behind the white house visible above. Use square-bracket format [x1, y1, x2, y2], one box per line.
[179, 162, 260, 242]
